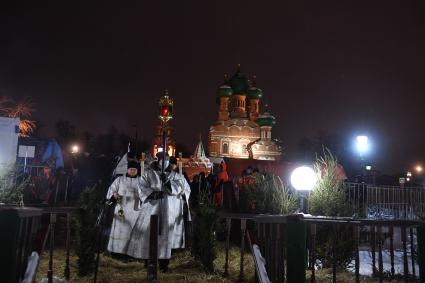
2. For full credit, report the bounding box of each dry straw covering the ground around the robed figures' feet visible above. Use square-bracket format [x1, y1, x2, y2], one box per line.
[36, 245, 255, 283]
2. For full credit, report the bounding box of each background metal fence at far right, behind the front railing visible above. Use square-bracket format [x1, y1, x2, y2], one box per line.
[345, 183, 425, 219]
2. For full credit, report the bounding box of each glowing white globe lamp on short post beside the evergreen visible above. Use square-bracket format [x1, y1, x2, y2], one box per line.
[291, 166, 317, 213]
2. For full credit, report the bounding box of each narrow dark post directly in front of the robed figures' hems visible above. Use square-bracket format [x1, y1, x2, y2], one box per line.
[148, 215, 159, 283]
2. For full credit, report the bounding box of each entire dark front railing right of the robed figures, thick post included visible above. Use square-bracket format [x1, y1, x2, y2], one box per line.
[220, 213, 425, 283]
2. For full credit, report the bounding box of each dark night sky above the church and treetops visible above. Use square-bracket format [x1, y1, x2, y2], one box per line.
[0, 0, 425, 172]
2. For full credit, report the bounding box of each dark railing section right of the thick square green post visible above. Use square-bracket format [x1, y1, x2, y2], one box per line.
[302, 216, 425, 282]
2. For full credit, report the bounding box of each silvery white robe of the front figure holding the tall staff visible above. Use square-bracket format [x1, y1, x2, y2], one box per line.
[127, 169, 190, 259]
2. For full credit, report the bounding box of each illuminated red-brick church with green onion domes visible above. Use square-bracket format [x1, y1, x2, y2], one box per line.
[208, 66, 282, 160]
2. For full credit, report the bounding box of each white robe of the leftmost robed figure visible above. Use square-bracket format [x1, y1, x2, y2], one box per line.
[106, 176, 140, 254]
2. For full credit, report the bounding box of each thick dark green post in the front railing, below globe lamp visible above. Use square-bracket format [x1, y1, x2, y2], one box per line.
[284, 215, 307, 283]
